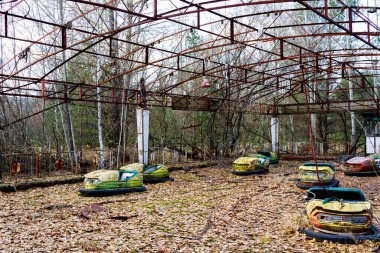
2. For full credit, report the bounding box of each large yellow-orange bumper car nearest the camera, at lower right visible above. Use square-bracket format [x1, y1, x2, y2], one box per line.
[299, 187, 380, 243]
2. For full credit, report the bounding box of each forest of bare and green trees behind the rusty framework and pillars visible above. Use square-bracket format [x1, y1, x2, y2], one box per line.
[0, 0, 376, 171]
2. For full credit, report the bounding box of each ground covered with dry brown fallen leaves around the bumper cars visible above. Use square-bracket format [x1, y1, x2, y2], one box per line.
[0, 162, 380, 252]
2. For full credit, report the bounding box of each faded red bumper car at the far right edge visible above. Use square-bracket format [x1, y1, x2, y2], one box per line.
[344, 157, 380, 177]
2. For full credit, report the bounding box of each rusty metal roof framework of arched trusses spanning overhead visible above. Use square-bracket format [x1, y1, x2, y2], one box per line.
[0, 0, 380, 123]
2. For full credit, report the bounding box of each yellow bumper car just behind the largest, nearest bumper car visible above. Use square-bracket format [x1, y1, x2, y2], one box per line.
[296, 162, 339, 189]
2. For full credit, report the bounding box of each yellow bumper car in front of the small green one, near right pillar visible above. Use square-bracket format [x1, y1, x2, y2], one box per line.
[231, 154, 269, 176]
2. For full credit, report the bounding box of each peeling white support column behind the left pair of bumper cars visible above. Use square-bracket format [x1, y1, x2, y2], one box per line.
[136, 108, 150, 164]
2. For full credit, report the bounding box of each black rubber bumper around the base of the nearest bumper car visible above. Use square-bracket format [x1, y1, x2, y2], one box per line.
[298, 225, 380, 243]
